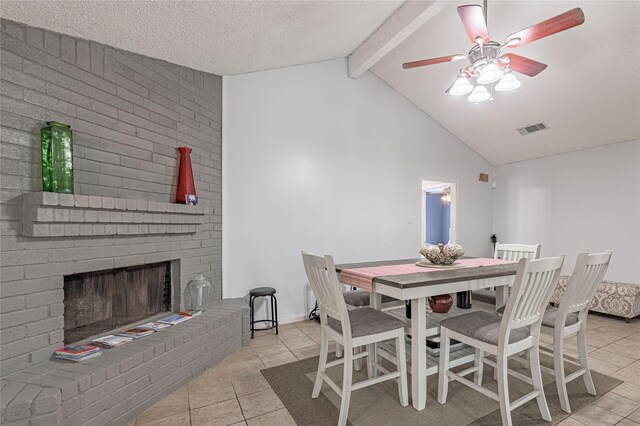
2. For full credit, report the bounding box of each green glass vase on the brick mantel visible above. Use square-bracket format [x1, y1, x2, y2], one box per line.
[40, 121, 73, 194]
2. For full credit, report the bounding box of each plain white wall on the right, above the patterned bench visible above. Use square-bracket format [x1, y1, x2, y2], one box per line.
[493, 140, 640, 283]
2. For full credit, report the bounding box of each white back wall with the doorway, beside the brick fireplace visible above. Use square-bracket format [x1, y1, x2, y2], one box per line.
[222, 59, 492, 319]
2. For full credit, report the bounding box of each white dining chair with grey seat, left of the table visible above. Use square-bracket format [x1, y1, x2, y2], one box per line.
[302, 252, 409, 425]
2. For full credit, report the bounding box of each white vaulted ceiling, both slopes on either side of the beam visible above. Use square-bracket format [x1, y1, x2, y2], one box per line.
[0, 0, 640, 165]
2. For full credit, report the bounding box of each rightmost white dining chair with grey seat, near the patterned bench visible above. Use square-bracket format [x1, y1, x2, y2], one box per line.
[540, 250, 613, 413]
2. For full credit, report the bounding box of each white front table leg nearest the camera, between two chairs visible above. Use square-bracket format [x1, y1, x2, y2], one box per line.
[411, 297, 427, 411]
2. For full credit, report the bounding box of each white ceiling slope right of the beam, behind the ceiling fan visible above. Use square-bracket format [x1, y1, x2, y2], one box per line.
[373, 1, 640, 165]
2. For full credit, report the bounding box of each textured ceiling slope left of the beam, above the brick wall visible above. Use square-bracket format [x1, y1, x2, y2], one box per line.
[0, 0, 404, 75]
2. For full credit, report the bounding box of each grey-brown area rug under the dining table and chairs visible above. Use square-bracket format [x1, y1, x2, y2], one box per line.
[262, 357, 622, 426]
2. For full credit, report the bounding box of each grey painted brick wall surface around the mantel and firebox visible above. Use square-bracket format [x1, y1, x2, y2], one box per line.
[0, 20, 222, 376]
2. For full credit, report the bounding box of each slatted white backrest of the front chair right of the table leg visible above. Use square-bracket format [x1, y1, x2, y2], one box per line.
[500, 255, 564, 336]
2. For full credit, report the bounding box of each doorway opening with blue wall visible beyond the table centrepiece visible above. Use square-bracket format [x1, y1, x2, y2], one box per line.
[421, 180, 457, 244]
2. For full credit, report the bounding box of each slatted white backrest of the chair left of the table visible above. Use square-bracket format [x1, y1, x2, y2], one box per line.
[302, 251, 351, 337]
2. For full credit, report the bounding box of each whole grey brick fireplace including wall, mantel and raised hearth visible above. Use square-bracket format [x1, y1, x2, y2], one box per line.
[0, 19, 246, 424]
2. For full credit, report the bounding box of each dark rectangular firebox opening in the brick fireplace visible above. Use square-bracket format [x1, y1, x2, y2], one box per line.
[64, 262, 171, 344]
